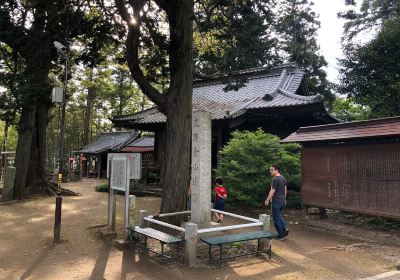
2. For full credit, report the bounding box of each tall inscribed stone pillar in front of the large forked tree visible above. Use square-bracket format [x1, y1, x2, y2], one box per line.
[191, 111, 211, 225]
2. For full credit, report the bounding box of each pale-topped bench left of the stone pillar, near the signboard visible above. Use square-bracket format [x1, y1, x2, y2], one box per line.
[128, 226, 183, 259]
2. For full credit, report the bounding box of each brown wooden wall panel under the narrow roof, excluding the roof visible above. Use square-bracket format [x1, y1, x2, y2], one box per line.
[302, 143, 400, 218]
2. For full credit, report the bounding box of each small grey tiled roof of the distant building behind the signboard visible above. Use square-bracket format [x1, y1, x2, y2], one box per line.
[76, 131, 139, 154]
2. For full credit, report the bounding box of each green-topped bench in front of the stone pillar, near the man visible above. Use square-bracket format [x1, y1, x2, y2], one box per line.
[200, 230, 276, 265]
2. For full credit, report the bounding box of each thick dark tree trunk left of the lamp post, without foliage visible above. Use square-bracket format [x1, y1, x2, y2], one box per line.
[14, 54, 51, 199]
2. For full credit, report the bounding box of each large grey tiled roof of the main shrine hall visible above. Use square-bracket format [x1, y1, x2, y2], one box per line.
[113, 64, 322, 124]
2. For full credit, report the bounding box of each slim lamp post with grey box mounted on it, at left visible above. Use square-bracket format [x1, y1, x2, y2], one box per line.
[53, 41, 68, 242]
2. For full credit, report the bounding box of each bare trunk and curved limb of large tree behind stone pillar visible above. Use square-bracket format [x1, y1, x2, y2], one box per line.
[115, 0, 194, 219]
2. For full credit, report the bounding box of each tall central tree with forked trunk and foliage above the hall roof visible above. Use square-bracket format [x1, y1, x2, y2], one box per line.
[108, 0, 280, 217]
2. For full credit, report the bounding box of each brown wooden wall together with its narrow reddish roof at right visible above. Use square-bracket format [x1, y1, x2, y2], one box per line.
[282, 117, 400, 218]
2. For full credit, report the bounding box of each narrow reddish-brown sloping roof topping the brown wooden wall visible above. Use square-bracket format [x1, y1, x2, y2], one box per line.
[282, 117, 400, 143]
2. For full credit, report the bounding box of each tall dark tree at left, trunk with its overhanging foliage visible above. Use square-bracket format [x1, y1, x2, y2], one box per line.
[0, 0, 115, 199]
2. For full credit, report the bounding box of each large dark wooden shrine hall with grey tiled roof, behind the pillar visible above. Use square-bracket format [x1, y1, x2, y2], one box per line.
[112, 64, 338, 167]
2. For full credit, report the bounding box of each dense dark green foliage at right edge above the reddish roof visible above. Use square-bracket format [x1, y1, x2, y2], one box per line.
[339, 17, 400, 117]
